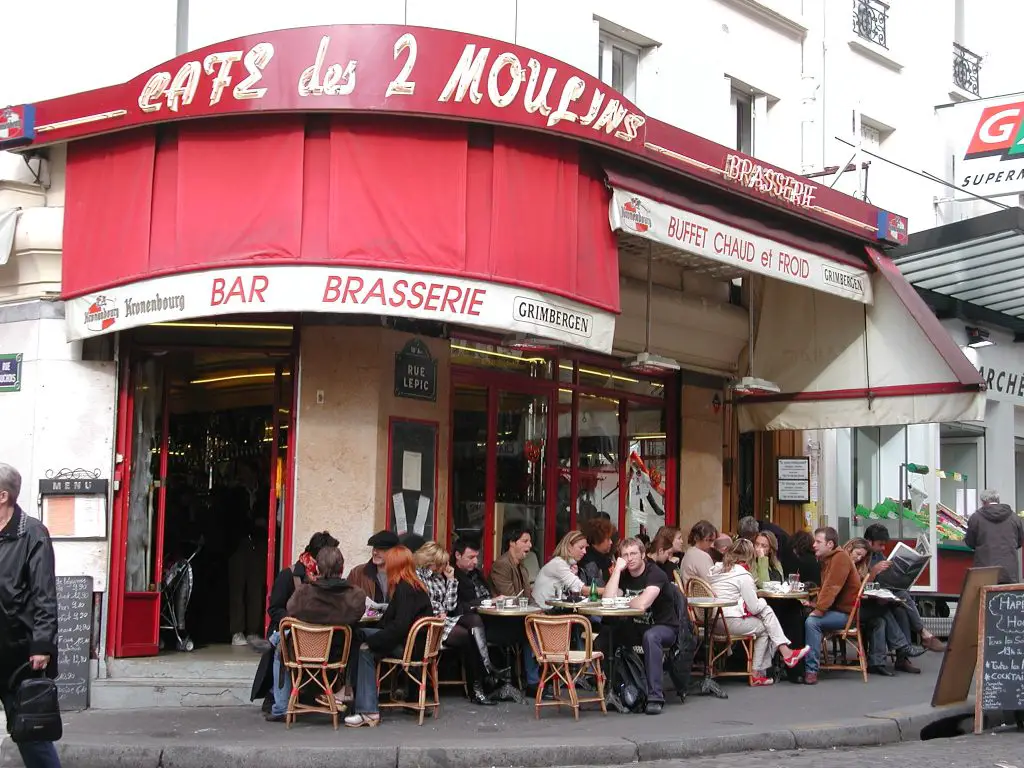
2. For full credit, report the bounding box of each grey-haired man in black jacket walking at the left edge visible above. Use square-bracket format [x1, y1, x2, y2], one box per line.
[0, 464, 60, 768]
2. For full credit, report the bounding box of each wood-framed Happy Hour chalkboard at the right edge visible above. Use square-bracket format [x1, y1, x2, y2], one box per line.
[977, 584, 1024, 724]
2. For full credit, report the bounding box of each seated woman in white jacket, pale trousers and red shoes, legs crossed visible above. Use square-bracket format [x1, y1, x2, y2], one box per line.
[711, 539, 810, 685]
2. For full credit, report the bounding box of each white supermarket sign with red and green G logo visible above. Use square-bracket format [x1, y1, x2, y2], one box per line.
[938, 93, 1024, 199]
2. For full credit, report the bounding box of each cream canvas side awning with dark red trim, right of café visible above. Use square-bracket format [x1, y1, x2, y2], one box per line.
[737, 248, 985, 432]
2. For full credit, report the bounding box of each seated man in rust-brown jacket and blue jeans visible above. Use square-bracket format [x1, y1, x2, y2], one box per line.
[804, 527, 860, 685]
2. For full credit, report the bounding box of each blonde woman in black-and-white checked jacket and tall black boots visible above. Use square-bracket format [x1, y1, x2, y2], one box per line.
[413, 542, 498, 707]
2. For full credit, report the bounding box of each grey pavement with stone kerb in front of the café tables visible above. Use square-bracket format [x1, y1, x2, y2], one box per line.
[0, 653, 969, 768]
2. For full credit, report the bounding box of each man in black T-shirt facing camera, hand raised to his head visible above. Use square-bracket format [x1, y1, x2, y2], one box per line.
[604, 539, 680, 715]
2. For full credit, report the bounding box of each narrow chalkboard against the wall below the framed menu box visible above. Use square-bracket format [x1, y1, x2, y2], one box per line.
[56, 577, 92, 712]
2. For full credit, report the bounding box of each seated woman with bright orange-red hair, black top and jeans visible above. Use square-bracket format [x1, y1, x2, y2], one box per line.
[345, 546, 433, 728]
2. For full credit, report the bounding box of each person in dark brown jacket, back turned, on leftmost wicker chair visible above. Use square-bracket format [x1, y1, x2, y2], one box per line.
[266, 547, 367, 722]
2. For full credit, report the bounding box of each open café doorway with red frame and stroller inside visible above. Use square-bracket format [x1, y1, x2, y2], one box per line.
[108, 324, 294, 657]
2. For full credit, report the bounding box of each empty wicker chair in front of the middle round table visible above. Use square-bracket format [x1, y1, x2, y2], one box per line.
[526, 615, 608, 720]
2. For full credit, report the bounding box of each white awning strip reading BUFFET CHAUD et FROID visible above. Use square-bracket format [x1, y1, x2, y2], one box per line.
[609, 188, 871, 304]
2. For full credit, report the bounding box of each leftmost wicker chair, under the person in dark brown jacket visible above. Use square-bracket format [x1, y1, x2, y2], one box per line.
[279, 618, 352, 730]
